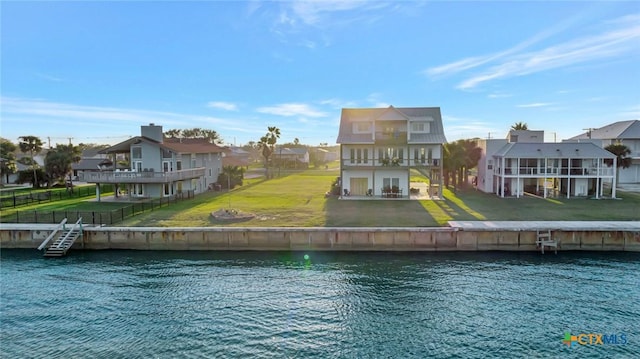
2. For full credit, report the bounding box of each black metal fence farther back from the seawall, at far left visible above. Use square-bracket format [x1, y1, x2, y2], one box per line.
[0, 184, 113, 209]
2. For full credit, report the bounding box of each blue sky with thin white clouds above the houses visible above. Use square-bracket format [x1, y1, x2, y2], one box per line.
[0, 1, 640, 145]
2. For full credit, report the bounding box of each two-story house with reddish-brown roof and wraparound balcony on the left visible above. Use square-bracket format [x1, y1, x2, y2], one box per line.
[79, 124, 226, 198]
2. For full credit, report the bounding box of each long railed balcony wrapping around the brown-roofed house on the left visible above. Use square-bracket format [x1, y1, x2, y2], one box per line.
[78, 167, 205, 183]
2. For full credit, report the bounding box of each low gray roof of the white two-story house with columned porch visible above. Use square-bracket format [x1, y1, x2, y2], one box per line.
[493, 142, 616, 159]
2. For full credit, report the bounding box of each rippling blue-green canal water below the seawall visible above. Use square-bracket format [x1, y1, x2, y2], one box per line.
[0, 250, 640, 358]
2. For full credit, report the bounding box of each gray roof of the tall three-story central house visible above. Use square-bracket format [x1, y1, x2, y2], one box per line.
[336, 106, 447, 144]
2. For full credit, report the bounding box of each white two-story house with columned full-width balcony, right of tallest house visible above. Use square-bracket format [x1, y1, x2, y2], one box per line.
[475, 131, 616, 198]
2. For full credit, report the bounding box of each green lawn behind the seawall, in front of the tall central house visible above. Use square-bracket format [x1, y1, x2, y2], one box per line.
[111, 169, 640, 227]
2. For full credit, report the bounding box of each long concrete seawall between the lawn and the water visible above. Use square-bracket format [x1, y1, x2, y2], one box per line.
[0, 222, 640, 252]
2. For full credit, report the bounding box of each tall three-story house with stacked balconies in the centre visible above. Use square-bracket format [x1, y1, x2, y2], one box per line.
[336, 106, 447, 198]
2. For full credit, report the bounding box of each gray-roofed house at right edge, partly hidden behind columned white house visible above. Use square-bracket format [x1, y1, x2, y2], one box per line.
[565, 120, 640, 183]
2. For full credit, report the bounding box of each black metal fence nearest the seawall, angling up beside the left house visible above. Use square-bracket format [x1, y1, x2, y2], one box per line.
[2, 191, 195, 225]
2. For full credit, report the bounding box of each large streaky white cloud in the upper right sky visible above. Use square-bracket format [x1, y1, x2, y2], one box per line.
[425, 16, 640, 90]
